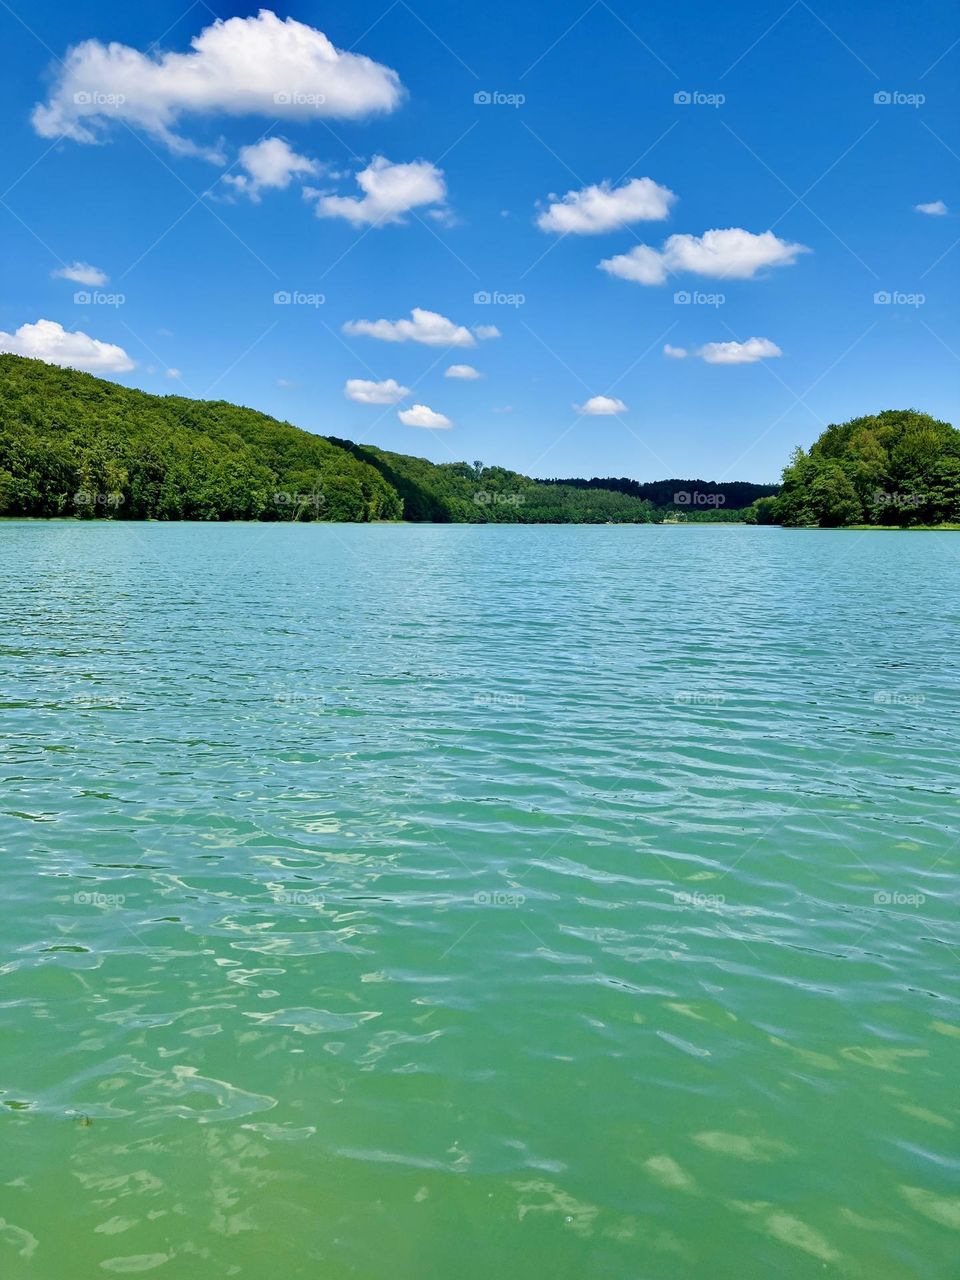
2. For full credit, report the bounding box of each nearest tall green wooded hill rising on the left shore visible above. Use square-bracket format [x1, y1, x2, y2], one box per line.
[0, 355, 402, 521]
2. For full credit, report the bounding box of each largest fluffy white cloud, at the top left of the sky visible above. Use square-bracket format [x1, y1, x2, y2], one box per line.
[32, 9, 403, 159]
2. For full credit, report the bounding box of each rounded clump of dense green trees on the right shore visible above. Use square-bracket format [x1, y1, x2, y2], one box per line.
[767, 410, 960, 529]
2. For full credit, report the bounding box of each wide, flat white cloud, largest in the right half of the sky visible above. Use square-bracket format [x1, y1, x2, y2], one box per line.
[599, 227, 810, 284]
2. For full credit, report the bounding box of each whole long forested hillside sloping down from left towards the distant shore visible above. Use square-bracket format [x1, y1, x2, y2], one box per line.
[0, 355, 771, 524]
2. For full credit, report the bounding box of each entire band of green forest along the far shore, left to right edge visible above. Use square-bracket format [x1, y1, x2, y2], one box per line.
[0, 355, 960, 529]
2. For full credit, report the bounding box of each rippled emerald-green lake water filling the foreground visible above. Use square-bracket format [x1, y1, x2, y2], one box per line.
[0, 522, 960, 1280]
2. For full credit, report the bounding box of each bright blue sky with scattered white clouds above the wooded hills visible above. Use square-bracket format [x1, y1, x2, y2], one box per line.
[0, 0, 960, 480]
